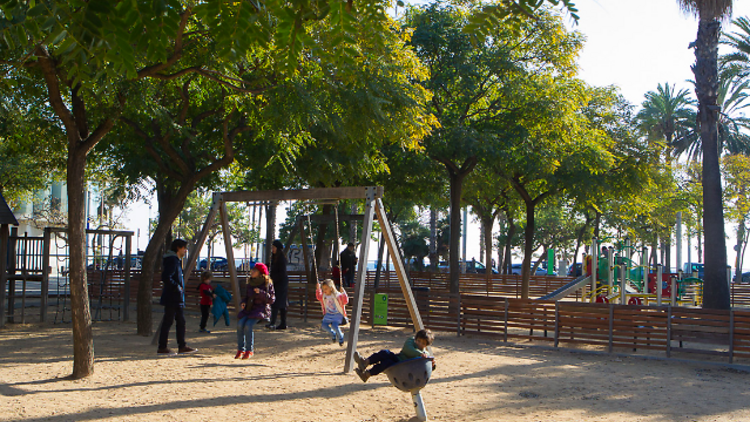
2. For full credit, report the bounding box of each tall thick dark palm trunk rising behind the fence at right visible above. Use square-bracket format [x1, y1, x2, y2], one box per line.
[677, 0, 732, 309]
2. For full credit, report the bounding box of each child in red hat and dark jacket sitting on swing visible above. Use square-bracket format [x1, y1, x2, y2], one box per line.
[234, 263, 276, 359]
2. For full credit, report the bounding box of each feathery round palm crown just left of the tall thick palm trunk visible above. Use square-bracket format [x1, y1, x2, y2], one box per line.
[636, 83, 695, 145]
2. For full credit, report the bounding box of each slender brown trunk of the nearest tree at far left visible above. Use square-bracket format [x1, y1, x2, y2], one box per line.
[67, 149, 94, 379]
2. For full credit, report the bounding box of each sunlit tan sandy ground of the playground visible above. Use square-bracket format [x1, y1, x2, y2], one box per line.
[0, 314, 750, 422]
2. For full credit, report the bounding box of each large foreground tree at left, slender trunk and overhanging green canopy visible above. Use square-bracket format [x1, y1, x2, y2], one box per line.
[0, 0, 396, 378]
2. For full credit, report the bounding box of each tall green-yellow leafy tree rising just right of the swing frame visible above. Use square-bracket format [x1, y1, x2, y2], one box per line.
[404, 3, 580, 292]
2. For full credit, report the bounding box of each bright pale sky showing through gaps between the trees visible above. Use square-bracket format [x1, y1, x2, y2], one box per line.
[119, 0, 750, 265]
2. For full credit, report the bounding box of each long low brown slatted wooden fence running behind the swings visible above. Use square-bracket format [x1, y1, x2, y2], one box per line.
[26, 271, 750, 362]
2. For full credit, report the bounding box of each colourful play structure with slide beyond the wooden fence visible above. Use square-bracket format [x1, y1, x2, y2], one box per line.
[540, 239, 703, 306]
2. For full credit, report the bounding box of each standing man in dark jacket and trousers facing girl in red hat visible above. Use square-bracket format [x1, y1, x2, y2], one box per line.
[157, 239, 198, 354]
